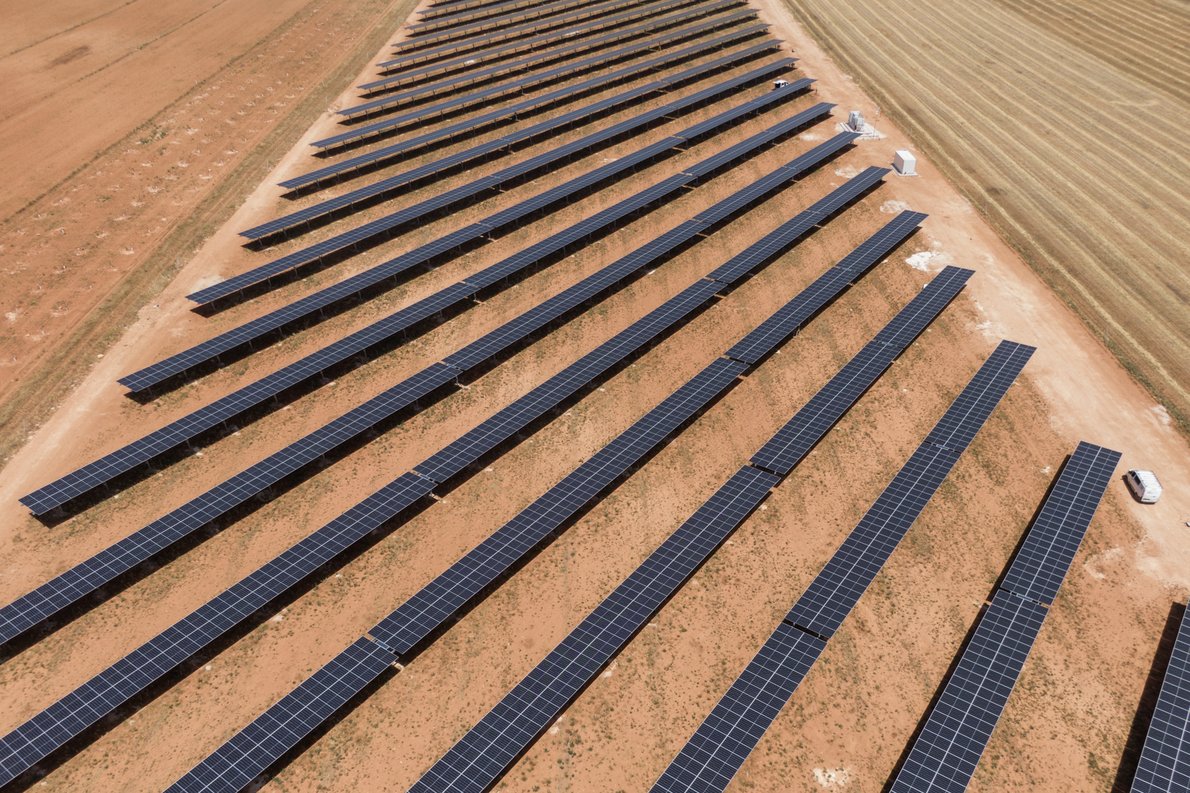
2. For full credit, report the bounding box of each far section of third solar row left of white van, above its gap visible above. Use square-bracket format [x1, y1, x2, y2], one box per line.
[752, 267, 971, 476]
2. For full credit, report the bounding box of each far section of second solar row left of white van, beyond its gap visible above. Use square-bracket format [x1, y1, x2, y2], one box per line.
[785, 333, 1034, 638]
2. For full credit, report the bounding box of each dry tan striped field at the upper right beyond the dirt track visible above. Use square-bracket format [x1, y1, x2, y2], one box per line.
[785, 0, 1190, 432]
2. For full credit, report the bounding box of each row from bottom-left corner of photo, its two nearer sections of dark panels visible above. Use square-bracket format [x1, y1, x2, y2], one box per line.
[0, 163, 885, 785]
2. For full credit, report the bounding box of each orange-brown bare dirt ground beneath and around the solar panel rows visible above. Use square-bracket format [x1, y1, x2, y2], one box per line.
[0, 0, 1190, 792]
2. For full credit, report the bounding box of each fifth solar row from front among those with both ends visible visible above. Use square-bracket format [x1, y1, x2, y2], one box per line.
[299, 16, 768, 189]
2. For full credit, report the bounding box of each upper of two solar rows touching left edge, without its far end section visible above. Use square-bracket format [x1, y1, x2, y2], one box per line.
[0, 137, 856, 662]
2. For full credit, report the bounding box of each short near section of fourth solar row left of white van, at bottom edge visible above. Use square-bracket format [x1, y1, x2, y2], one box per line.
[169, 638, 393, 793]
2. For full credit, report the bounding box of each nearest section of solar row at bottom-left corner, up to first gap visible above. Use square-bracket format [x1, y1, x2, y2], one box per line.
[0, 474, 434, 785]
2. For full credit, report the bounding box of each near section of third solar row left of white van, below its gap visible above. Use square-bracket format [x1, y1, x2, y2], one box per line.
[409, 271, 966, 793]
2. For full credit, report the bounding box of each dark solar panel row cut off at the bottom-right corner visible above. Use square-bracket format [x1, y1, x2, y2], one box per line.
[1132, 600, 1190, 793]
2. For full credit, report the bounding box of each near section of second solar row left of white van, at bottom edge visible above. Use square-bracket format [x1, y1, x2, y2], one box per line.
[652, 623, 826, 793]
